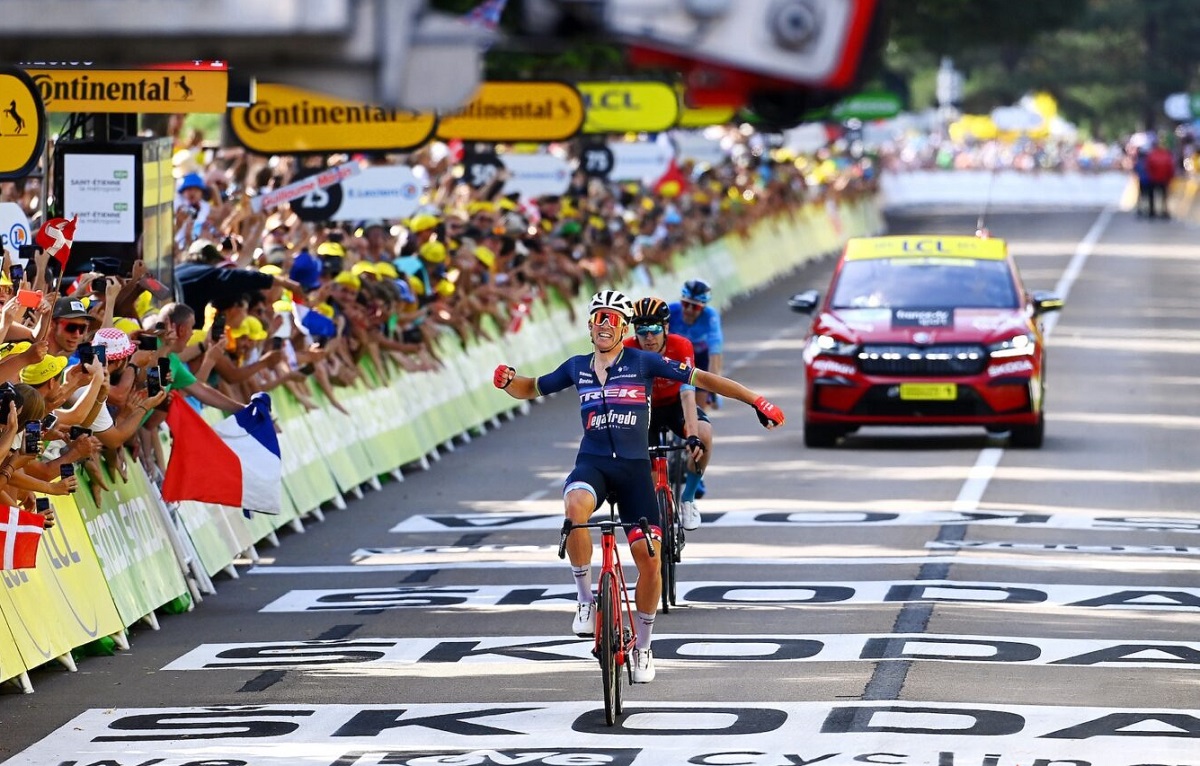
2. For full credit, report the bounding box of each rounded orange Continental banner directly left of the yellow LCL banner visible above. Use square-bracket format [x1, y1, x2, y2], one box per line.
[438, 82, 584, 142]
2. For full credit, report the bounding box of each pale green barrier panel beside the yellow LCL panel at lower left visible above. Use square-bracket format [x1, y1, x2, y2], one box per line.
[76, 461, 187, 626]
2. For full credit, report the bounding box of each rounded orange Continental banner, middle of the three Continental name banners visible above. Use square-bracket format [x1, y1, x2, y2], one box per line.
[229, 83, 438, 154]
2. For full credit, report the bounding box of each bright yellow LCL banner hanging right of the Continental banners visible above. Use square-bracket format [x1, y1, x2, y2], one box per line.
[576, 83, 679, 133]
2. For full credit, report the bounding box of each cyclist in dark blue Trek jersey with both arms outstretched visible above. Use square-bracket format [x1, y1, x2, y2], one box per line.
[492, 289, 784, 683]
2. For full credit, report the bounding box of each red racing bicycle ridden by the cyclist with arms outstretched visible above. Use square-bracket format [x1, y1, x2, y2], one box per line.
[558, 499, 654, 726]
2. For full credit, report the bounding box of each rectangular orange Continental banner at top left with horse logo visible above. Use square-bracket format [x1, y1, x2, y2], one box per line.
[26, 68, 229, 114]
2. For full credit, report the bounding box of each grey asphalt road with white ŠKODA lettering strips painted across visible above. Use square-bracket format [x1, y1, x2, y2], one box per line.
[0, 205, 1200, 766]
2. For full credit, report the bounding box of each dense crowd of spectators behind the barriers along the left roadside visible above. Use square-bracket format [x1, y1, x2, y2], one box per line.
[0, 124, 868, 523]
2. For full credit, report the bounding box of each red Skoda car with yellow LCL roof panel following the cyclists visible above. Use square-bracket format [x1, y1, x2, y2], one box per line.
[788, 235, 1062, 448]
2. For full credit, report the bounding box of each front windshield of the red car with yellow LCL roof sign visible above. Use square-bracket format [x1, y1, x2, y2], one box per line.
[830, 257, 1020, 309]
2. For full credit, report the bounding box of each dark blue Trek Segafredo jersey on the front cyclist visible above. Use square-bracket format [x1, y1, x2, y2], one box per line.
[536, 348, 694, 460]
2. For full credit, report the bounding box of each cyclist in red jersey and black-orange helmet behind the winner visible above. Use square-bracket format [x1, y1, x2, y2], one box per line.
[625, 298, 713, 529]
